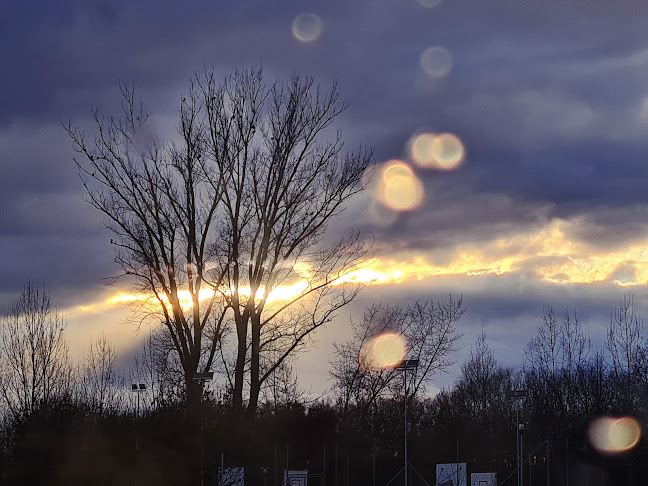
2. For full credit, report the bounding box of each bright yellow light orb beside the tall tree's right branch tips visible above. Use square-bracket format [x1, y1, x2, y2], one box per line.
[379, 160, 424, 211]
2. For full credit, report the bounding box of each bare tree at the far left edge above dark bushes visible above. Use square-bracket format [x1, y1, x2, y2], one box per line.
[0, 282, 71, 418]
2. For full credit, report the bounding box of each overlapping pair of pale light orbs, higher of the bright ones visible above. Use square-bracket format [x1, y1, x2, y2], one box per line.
[410, 133, 465, 170]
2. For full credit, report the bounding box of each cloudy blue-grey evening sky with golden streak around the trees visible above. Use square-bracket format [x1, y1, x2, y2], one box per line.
[0, 0, 648, 389]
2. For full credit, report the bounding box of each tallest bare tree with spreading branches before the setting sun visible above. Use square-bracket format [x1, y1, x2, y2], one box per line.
[65, 69, 372, 414]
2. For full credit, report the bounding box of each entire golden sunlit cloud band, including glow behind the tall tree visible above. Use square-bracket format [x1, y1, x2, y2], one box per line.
[71, 217, 648, 317]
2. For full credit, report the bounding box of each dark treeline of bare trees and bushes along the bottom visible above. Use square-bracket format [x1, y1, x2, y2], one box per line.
[0, 284, 648, 486]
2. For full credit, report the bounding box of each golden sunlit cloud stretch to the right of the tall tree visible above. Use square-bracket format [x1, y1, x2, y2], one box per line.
[336, 219, 648, 287]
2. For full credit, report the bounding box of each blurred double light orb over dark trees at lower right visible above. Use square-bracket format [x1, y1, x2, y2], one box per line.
[587, 417, 641, 454]
